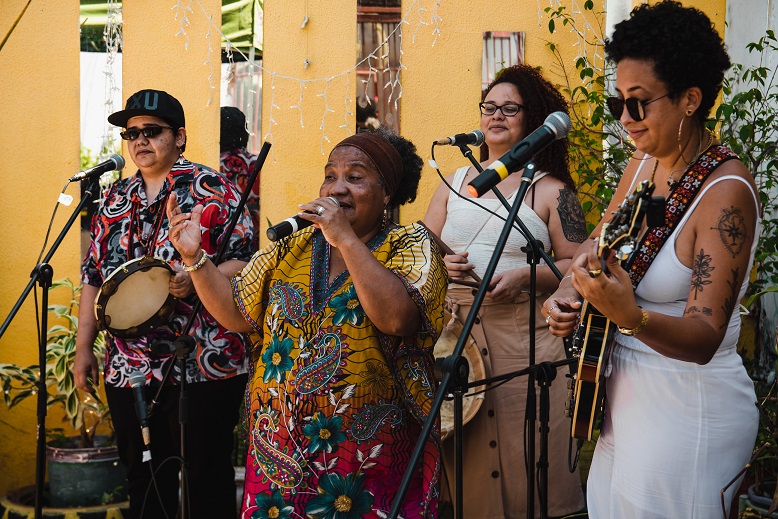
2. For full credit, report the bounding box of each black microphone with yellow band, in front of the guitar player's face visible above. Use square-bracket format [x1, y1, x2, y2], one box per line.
[467, 112, 571, 197]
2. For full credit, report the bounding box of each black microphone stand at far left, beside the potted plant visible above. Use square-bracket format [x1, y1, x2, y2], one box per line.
[0, 180, 97, 519]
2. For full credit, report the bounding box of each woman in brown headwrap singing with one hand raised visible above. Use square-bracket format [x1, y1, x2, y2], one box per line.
[168, 132, 446, 518]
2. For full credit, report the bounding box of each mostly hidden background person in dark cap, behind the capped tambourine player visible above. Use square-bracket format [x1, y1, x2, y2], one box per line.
[219, 106, 260, 248]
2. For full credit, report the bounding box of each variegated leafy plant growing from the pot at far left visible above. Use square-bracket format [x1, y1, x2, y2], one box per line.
[0, 279, 110, 447]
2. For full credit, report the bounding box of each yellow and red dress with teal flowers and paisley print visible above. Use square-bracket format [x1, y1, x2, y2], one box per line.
[233, 224, 447, 519]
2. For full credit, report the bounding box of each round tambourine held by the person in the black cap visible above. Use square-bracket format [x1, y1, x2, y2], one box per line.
[95, 256, 178, 339]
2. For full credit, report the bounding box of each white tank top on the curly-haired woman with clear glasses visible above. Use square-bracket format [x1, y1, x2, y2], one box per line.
[440, 166, 551, 276]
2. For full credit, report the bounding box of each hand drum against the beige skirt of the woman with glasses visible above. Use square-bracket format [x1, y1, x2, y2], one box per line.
[435, 309, 486, 439]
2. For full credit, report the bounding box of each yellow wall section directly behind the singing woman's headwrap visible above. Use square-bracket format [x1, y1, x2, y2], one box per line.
[260, 0, 357, 244]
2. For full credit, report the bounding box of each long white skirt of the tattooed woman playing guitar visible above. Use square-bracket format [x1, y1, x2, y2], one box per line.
[587, 344, 759, 519]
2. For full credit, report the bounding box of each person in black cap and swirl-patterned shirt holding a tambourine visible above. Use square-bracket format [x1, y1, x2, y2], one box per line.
[73, 90, 255, 519]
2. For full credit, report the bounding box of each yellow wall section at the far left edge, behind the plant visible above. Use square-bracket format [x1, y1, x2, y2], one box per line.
[0, 0, 80, 494]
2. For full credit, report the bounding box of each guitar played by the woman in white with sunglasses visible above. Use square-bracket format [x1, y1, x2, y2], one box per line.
[567, 180, 654, 440]
